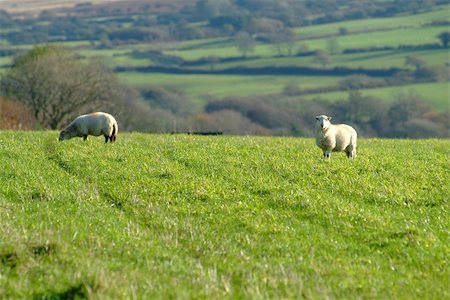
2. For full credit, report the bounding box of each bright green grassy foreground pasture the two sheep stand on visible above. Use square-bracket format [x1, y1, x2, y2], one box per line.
[0, 132, 450, 299]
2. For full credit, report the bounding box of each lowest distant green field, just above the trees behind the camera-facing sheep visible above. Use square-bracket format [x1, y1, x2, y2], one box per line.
[302, 82, 450, 112]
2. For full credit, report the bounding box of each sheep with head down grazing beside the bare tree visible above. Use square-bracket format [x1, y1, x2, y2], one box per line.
[59, 112, 119, 143]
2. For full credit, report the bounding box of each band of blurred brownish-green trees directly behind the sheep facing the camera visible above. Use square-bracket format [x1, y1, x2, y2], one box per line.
[184, 91, 450, 138]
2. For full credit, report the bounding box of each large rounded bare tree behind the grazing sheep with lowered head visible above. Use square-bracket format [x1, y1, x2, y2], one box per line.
[0, 46, 124, 129]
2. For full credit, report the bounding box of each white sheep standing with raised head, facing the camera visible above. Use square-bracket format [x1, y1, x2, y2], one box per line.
[316, 115, 357, 158]
